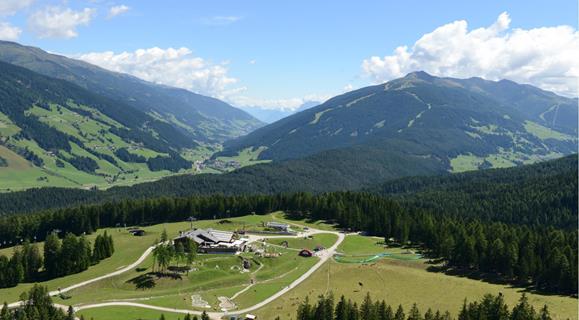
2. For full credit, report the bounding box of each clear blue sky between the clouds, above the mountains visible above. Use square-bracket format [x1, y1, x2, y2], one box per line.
[0, 0, 577, 107]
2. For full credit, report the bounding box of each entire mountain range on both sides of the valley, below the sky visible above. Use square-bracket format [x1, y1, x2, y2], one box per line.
[0, 41, 578, 195]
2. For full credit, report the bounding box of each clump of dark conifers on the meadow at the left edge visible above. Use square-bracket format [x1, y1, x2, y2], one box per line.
[0, 231, 115, 288]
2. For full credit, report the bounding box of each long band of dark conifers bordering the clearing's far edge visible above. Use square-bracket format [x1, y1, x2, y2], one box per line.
[0, 192, 577, 294]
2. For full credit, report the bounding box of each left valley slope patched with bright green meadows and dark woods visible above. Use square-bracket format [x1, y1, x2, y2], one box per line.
[0, 62, 216, 191]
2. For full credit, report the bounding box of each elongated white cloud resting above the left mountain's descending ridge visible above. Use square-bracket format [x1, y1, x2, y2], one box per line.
[75, 47, 240, 99]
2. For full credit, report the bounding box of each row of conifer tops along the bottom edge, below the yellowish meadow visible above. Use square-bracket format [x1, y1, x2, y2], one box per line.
[292, 293, 552, 320]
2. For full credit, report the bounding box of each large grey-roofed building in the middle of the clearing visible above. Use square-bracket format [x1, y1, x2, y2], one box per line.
[173, 229, 247, 253]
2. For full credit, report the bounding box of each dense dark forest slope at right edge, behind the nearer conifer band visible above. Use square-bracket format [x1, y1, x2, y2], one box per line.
[368, 155, 579, 229]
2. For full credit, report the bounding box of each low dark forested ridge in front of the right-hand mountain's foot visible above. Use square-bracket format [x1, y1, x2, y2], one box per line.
[0, 140, 444, 214]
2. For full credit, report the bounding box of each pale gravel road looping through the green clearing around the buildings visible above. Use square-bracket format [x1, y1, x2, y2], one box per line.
[9, 220, 345, 320]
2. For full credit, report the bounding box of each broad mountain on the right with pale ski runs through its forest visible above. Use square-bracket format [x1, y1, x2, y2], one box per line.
[222, 72, 577, 171]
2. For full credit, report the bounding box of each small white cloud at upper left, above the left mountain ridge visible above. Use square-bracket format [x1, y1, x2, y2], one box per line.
[28, 7, 96, 39]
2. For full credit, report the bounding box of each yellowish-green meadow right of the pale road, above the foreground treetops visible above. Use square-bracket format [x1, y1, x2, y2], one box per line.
[255, 236, 578, 320]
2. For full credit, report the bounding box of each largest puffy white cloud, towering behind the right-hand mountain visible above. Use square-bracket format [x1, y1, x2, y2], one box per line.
[362, 12, 579, 96]
